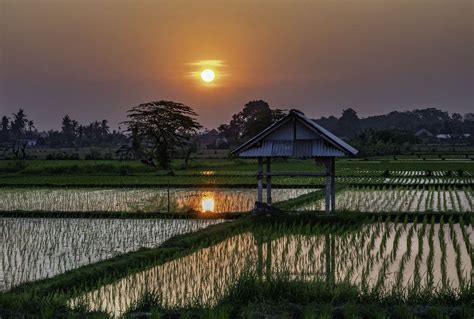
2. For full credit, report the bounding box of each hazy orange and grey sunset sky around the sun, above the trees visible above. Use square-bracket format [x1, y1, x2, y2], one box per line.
[0, 0, 474, 130]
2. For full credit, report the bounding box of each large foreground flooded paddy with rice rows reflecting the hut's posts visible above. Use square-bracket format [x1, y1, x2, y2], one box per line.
[69, 219, 474, 317]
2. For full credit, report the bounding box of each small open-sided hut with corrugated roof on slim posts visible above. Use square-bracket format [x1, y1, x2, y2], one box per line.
[232, 110, 358, 213]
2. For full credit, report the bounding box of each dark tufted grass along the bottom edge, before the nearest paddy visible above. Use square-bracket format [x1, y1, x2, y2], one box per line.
[125, 273, 474, 319]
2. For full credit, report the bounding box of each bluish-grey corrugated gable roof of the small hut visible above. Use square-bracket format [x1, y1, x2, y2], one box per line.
[232, 110, 358, 157]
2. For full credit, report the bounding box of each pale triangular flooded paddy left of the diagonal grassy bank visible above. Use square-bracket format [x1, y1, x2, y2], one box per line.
[0, 218, 220, 291]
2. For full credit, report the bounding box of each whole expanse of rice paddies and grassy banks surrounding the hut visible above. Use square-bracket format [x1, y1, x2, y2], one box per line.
[0, 161, 474, 318]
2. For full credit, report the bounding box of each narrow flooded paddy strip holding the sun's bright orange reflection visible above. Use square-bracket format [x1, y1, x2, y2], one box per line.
[0, 188, 315, 213]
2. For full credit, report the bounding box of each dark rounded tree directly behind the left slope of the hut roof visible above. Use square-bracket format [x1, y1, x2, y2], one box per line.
[218, 100, 284, 144]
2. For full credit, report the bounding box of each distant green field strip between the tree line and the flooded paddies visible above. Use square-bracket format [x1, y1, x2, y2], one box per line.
[0, 159, 474, 187]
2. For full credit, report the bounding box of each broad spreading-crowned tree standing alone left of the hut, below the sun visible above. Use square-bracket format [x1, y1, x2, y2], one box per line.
[124, 100, 202, 169]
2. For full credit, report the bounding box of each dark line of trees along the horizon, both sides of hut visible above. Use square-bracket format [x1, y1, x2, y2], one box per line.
[0, 100, 474, 168]
